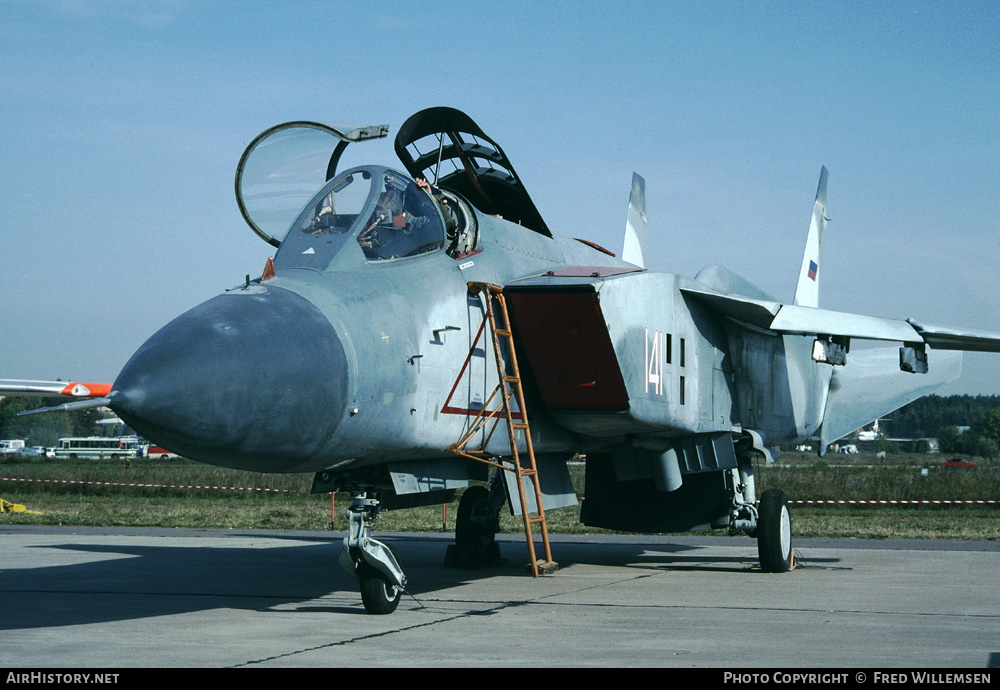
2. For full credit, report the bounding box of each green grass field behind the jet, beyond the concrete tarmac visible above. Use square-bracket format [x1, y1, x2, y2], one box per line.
[0, 452, 1000, 539]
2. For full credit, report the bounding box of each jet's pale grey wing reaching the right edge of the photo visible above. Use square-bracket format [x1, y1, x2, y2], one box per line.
[681, 286, 1000, 352]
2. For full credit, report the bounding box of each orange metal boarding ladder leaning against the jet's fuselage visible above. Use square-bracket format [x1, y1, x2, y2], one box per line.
[448, 282, 558, 577]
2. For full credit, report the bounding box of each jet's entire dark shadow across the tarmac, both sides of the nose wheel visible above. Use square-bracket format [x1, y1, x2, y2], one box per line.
[0, 537, 844, 629]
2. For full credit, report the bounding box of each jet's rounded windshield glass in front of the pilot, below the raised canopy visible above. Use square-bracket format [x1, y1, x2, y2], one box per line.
[274, 167, 444, 270]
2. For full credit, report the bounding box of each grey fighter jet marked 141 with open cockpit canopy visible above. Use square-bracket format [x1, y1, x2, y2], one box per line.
[7, 107, 1000, 614]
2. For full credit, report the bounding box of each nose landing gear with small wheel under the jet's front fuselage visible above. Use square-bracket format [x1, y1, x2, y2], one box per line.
[340, 489, 406, 615]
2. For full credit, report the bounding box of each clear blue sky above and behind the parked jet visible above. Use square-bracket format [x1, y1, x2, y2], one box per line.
[0, 0, 1000, 394]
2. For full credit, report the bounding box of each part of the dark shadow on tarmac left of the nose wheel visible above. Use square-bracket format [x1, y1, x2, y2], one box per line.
[0, 540, 349, 628]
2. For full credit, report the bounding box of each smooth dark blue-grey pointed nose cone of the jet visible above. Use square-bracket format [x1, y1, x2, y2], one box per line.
[109, 287, 348, 471]
